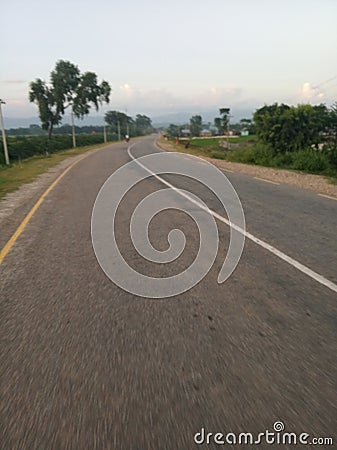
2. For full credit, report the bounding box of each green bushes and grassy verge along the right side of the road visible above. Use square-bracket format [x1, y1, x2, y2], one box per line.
[166, 103, 337, 180]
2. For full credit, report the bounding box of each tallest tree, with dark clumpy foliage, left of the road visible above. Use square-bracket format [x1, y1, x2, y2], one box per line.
[29, 60, 111, 139]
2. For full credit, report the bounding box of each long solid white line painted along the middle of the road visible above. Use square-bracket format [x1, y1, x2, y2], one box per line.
[128, 144, 337, 292]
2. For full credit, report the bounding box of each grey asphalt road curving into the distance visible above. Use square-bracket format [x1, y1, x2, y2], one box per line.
[0, 137, 337, 450]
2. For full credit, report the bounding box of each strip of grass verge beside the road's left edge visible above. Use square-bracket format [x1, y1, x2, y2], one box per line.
[0, 142, 111, 199]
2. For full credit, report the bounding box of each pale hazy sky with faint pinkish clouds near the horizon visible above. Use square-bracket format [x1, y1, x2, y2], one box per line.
[0, 0, 337, 123]
